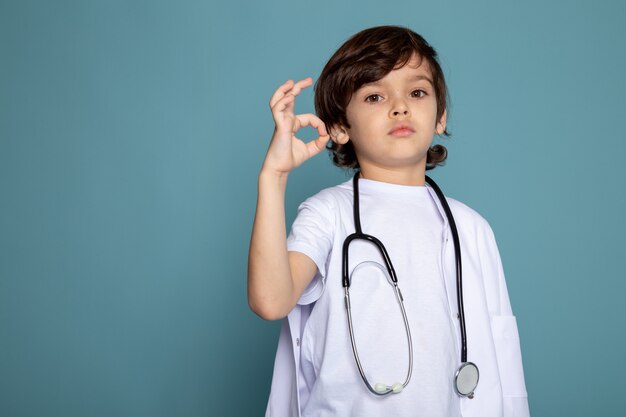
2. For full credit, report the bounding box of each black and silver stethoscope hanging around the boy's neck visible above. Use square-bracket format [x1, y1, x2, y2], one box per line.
[342, 171, 478, 398]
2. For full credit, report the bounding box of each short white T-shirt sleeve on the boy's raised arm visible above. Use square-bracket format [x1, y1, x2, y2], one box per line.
[287, 194, 335, 305]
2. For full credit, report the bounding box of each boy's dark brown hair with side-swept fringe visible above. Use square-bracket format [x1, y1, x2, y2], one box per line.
[315, 26, 451, 170]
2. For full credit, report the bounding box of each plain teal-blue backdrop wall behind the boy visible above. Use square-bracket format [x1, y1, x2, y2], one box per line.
[0, 0, 626, 417]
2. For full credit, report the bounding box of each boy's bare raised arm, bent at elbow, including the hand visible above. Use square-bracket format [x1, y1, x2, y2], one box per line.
[248, 78, 329, 320]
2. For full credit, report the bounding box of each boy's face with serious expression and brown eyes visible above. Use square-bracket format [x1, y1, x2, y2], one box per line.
[336, 54, 446, 171]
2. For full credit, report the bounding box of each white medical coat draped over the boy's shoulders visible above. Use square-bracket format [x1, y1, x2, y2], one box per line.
[265, 183, 530, 417]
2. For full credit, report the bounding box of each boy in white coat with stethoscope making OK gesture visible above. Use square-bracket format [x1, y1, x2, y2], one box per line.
[248, 26, 529, 417]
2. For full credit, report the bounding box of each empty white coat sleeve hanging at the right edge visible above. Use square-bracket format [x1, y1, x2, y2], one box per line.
[479, 219, 530, 417]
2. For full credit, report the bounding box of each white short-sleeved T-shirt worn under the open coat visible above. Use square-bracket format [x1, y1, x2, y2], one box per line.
[287, 179, 460, 417]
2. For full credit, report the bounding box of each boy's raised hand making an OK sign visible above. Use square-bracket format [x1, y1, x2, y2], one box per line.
[263, 77, 330, 175]
